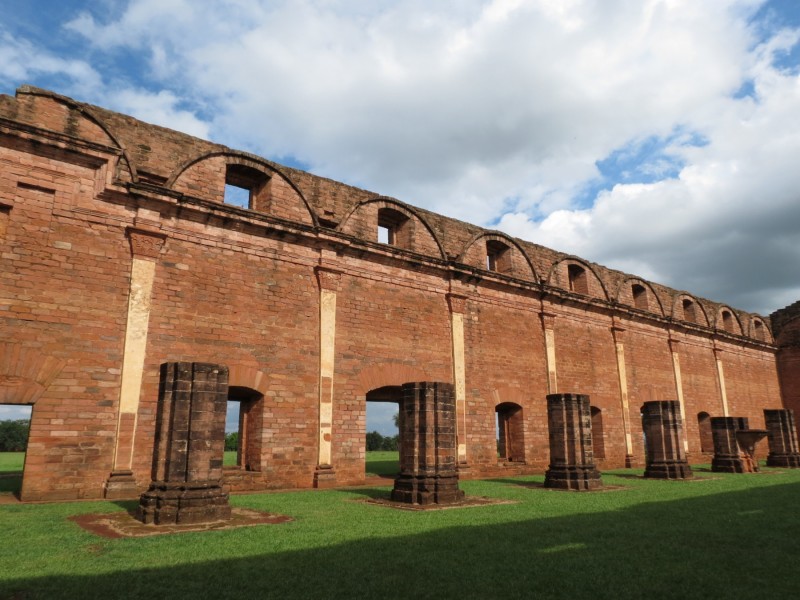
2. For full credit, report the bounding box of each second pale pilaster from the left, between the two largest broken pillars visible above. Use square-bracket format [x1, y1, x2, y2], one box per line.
[314, 266, 342, 488]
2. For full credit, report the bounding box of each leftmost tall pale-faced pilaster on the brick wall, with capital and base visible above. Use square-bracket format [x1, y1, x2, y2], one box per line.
[104, 228, 166, 498]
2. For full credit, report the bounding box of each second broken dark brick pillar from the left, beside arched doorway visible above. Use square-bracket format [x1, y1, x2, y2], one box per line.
[392, 381, 464, 504]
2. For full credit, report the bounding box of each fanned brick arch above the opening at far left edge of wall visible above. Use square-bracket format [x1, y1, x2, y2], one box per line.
[0, 342, 66, 404]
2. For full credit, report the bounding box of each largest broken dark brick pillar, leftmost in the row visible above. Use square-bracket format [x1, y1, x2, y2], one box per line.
[137, 362, 231, 525]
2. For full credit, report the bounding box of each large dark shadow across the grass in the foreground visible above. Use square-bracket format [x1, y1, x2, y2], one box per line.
[6, 483, 800, 600]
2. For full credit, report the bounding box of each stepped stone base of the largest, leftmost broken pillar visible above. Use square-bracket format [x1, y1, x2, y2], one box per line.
[136, 479, 231, 525]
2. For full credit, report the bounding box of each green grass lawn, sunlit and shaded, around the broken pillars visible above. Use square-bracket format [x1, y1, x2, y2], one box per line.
[0, 469, 800, 600]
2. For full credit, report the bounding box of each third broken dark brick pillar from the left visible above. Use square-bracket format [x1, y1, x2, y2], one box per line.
[544, 394, 603, 491]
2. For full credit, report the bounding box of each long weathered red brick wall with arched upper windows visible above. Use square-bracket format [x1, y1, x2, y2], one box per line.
[0, 87, 788, 500]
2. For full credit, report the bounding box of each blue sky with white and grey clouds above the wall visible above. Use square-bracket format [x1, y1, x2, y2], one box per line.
[0, 0, 800, 434]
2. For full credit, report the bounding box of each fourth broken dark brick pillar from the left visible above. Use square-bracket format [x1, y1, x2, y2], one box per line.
[642, 400, 692, 479]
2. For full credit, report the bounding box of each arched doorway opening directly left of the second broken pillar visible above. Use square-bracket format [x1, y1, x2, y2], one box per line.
[364, 385, 402, 478]
